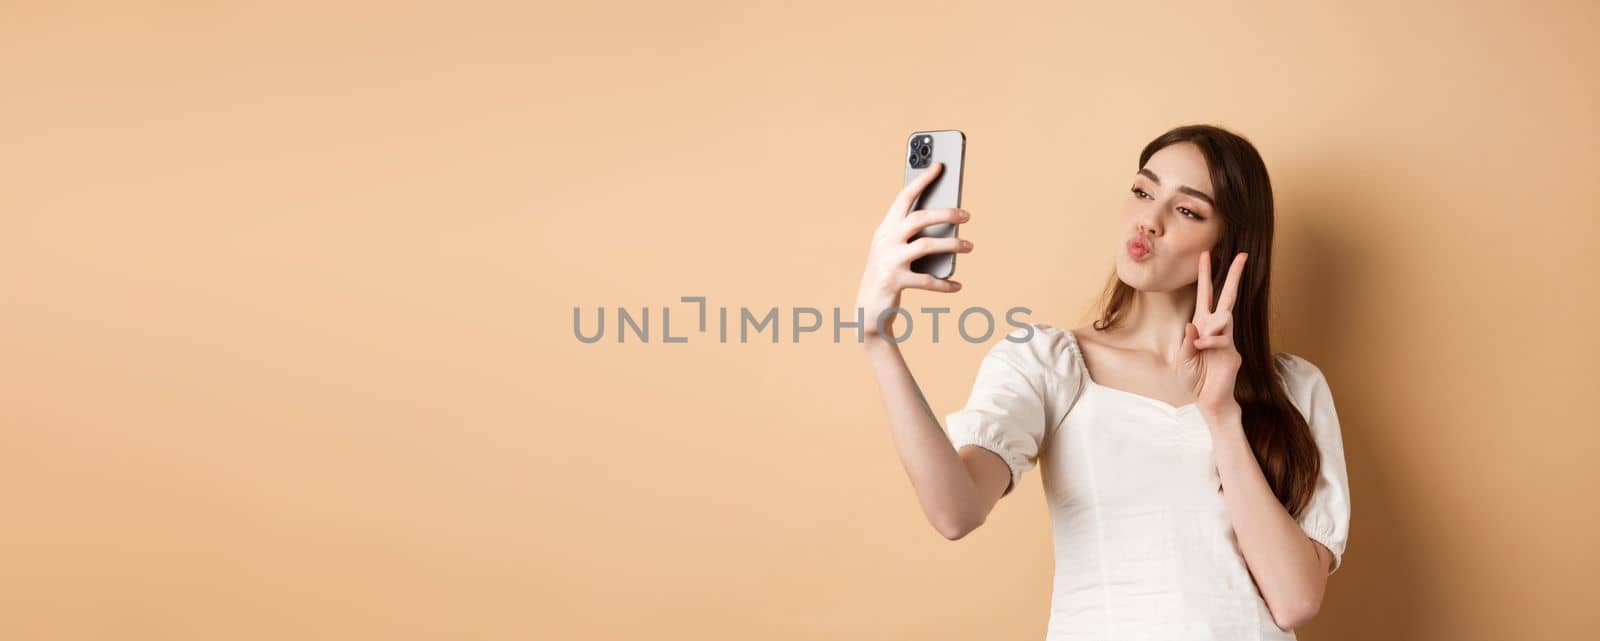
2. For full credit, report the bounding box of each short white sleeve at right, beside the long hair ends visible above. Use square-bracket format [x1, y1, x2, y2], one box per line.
[1278, 353, 1350, 575]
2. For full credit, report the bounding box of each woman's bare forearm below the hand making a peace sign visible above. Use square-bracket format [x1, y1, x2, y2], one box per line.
[1206, 409, 1328, 630]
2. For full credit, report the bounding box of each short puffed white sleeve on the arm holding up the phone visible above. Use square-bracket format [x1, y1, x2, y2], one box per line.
[946, 323, 1080, 497]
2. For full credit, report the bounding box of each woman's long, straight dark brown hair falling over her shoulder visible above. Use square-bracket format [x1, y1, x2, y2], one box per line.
[1094, 125, 1322, 518]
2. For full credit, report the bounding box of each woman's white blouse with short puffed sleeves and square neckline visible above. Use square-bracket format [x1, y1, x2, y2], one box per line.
[946, 323, 1350, 641]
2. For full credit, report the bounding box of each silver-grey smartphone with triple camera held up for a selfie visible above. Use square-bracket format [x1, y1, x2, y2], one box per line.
[901, 129, 966, 280]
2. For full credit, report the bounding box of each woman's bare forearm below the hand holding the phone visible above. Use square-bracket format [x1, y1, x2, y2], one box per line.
[866, 337, 981, 537]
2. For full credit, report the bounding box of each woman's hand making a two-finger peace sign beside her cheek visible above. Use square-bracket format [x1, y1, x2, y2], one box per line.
[1178, 251, 1248, 417]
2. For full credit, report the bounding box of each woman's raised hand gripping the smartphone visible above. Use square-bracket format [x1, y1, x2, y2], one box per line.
[856, 163, 973, 339]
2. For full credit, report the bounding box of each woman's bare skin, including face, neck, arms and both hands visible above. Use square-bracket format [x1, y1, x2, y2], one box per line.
[856, 142, 1333, 630]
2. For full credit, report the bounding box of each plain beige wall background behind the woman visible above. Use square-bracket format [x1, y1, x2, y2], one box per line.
[0, 2, 1600, 639]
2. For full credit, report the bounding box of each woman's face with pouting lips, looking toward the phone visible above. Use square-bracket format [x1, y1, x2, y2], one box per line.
[1117, 142, 1222, 291]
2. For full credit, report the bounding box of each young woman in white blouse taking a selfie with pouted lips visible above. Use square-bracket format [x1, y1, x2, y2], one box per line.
[858, 125, 1350, 641]
